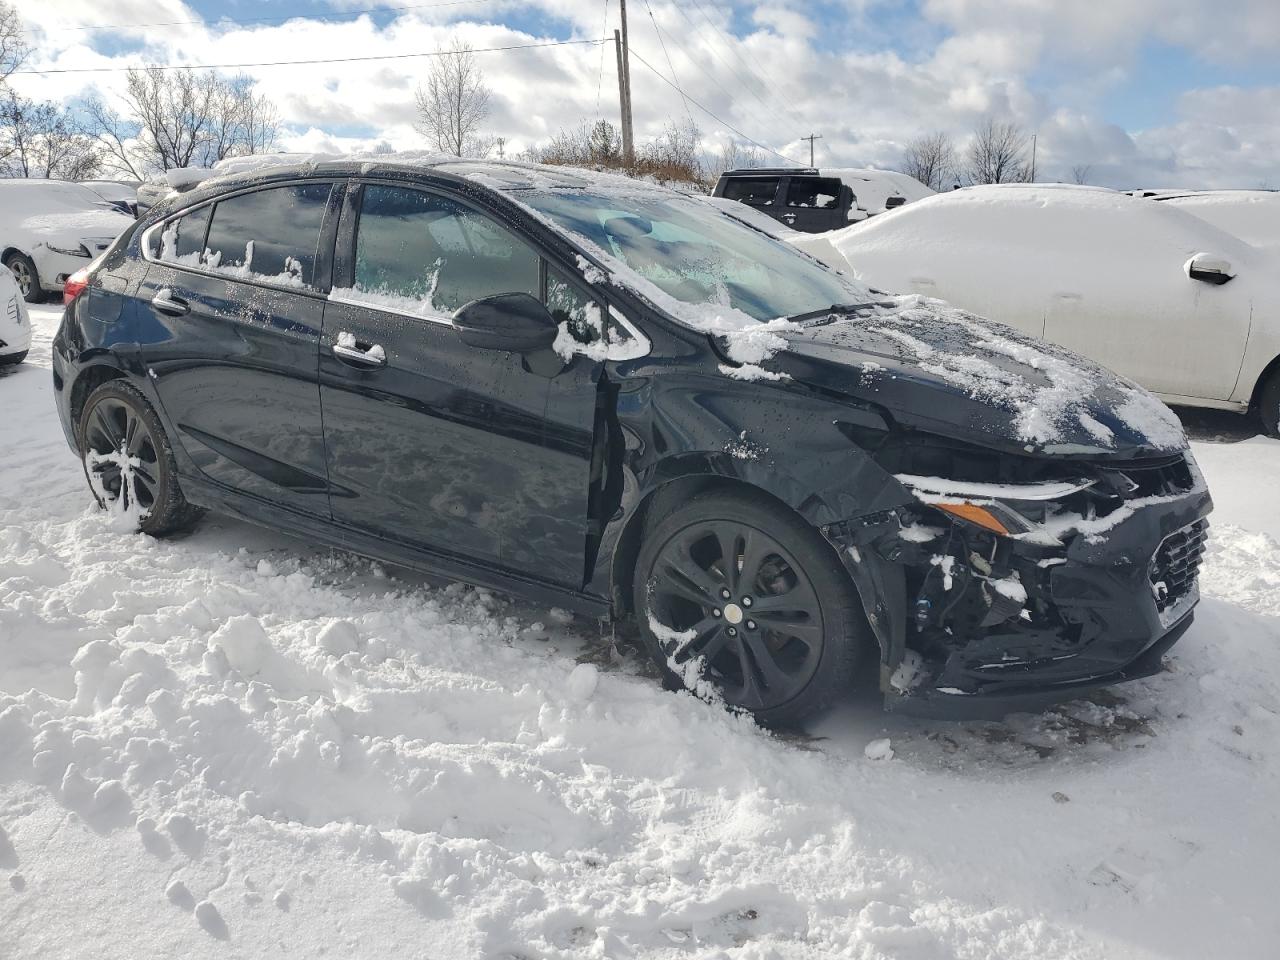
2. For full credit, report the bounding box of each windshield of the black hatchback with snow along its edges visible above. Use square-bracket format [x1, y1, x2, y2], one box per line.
[520, 191, 867, 321]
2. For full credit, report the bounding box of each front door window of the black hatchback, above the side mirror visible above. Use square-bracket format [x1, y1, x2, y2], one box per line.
[355, 184, 541, 316]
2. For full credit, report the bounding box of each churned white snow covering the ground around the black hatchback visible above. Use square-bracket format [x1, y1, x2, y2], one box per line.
[0, 307, 1280, 960]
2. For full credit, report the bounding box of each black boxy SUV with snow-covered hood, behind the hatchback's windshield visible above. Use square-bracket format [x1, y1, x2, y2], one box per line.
[712, 168, 933, 233]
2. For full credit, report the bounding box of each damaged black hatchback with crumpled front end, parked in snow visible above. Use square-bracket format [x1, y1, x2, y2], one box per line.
[54, 159, 1211, 722]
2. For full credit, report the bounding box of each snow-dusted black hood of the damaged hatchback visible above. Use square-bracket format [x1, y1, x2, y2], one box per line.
[771, 296, 1187, 458]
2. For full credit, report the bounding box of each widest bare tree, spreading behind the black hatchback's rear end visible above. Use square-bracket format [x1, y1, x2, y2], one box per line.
[84, 67, 279, 179]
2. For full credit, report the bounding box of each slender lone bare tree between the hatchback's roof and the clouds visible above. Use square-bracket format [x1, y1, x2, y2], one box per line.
[416, 38, 493, 156]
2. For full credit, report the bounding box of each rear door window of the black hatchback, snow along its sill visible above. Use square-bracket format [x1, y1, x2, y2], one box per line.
[202, 183, 330, 287]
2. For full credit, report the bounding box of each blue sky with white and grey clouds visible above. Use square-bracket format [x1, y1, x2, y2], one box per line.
[7, 0, 1280, 186]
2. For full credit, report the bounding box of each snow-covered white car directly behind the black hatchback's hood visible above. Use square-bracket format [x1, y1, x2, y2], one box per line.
[814, 184, 1280, 435]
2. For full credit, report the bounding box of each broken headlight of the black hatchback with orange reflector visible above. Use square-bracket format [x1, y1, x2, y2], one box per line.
[895, 474, 1097, 536]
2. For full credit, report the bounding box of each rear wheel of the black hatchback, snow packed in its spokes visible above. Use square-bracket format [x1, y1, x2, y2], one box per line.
[78, 380, 204, 536]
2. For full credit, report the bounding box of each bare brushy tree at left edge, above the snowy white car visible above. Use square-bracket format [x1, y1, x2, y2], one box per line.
[0, 91, 102, 180]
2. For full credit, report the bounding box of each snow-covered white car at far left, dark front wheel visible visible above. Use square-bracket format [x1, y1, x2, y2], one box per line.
[0, 179, 133, 303]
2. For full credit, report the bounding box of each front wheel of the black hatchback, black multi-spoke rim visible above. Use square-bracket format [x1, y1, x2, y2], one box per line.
[632, 492, 872, 726]
